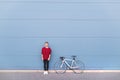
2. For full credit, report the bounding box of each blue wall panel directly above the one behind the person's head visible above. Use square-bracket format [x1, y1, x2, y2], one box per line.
[0, 21, 120, 38]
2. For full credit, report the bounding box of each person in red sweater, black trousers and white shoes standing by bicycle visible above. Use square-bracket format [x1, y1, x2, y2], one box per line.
[42, 42, 51, 75]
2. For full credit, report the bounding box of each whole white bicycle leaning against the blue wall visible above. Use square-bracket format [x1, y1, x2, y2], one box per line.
[54, 56, 85, 74]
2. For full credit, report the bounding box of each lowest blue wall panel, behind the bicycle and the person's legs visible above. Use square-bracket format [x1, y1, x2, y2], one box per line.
[0, 55, 120, 70]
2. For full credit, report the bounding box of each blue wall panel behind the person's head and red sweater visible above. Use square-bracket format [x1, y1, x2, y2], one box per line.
[0, 38, 120, 56]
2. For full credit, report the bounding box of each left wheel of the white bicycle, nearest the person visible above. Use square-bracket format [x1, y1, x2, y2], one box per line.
[54, 60, 66, 74]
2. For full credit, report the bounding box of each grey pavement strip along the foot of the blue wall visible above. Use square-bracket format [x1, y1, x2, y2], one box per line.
[0, 72, 120, 80]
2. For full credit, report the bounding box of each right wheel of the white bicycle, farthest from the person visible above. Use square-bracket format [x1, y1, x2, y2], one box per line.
[72, 60, 85, 74]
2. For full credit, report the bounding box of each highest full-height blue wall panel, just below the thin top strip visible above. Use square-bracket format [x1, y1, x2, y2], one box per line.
[0, 3, 120, 20]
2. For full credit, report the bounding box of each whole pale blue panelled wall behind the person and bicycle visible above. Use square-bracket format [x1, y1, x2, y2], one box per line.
[0, 0, 120, 69]
